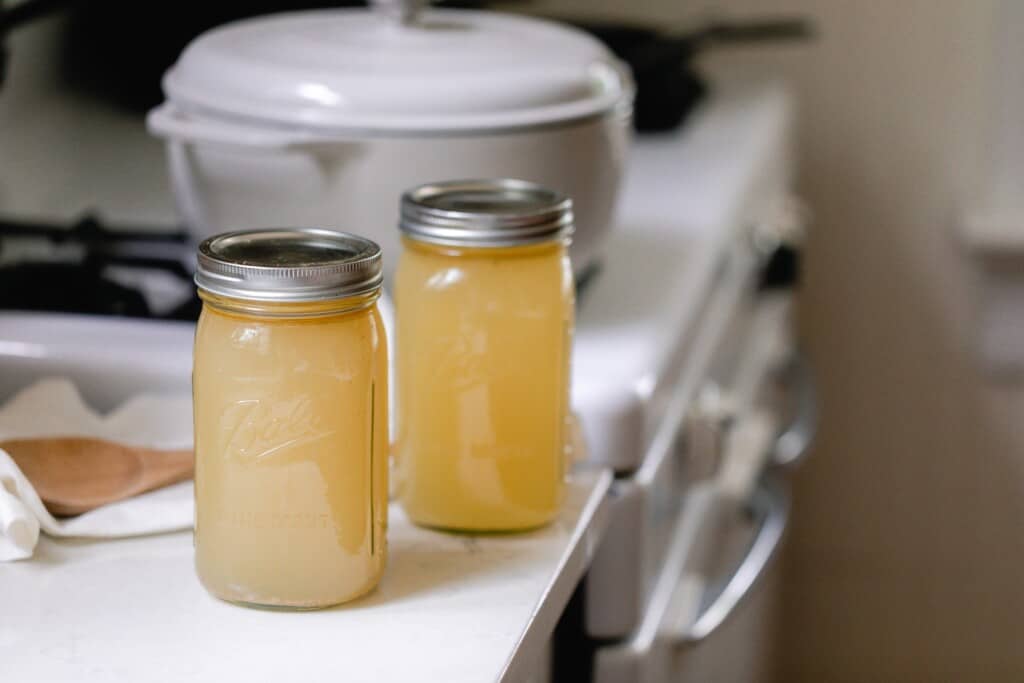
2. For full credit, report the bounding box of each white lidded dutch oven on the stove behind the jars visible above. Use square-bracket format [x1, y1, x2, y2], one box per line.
[148, 0, 633, 272]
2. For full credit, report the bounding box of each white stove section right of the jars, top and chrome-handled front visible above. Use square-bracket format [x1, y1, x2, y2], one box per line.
[573, 78, 813, 682]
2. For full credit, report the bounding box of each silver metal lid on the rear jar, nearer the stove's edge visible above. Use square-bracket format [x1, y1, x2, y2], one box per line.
[398, 178, 572, 247]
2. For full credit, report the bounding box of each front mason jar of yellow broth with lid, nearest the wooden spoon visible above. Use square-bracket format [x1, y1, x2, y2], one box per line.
[193, 229, 388, 609]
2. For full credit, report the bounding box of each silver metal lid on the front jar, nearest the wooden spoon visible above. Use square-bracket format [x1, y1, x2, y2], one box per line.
[196, 227, 382, 302]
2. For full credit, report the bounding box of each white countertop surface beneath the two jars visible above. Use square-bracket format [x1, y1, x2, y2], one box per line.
[0, 472, 611, 683]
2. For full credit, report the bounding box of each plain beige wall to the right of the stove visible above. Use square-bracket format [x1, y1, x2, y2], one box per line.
[532, 0, 1024, 683]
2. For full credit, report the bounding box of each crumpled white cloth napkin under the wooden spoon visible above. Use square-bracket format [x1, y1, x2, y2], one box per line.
[0, 379, 193, 562]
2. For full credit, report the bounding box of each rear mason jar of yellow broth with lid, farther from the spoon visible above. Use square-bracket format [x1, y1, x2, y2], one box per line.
[394, 180, 574, 531]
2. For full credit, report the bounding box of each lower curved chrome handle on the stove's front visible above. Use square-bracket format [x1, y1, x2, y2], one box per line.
[677, 477, 790, 646]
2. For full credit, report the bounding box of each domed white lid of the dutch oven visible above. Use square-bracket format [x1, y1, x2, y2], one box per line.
[164, 0, 633, 132]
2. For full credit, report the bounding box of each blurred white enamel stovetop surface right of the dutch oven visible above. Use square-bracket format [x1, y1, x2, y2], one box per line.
[572, 80, 793, 472]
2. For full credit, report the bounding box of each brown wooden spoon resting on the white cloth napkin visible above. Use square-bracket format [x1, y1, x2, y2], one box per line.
[0, 437, 194, 516]
